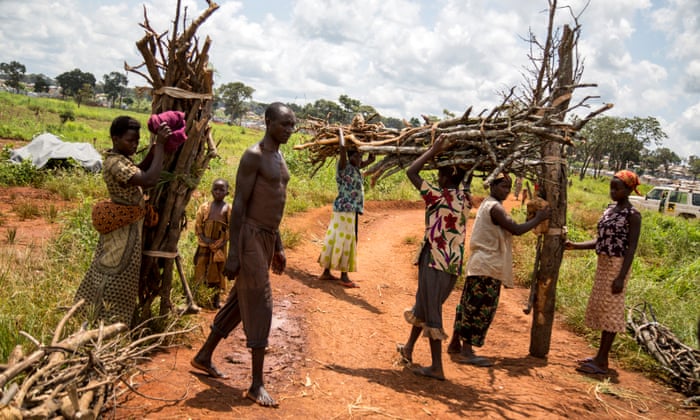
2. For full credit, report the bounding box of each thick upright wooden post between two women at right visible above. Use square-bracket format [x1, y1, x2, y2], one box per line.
[530, 25, 574, 357]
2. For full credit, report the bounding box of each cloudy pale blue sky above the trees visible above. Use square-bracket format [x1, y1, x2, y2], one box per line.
[0, 0, 700, 157]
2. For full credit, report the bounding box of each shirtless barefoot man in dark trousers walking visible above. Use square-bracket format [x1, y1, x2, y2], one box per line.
[191, 102, 296, 407]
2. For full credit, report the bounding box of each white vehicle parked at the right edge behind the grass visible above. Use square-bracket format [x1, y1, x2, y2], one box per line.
[630, 185, 700, 219]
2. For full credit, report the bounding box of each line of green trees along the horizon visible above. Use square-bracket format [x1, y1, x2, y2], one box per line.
[0, 57, 700, 178]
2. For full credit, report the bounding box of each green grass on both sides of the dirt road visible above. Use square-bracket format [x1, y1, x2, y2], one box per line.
[0, 93, 700, 384]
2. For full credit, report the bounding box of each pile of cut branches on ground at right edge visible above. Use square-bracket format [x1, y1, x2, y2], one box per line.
[627, 303, 700, 405]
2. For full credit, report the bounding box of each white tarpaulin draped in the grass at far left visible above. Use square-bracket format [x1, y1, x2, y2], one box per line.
[10, 133, 102, 172]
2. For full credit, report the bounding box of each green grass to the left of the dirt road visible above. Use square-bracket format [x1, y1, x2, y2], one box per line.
[0, 93, 417, 360]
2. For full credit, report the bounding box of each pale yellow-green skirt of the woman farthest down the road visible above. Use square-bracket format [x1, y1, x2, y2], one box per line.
[318, 211, 357, 273]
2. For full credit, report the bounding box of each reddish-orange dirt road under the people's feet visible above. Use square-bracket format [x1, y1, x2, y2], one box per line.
[116, 202, 698, 419]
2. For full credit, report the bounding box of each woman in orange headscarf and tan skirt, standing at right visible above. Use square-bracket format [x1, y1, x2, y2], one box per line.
[565, 170, 642, 375]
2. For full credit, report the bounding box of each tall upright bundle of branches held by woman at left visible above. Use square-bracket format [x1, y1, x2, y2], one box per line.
[125, 1, 219, 321]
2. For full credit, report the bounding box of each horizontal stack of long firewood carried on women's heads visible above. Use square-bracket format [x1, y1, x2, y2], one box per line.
[294, 101, 575, 185]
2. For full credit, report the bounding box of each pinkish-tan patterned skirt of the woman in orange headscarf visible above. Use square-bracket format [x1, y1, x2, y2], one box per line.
[585, 254, 631, 333]
